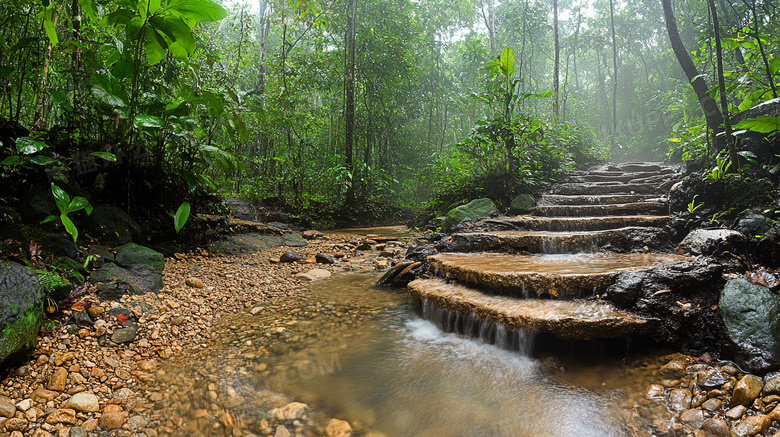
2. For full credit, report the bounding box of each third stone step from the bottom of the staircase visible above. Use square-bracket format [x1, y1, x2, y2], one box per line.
[437, 226, 674, 254]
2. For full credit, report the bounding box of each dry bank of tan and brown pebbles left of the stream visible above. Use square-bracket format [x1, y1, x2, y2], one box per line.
[0, 228, 414, 437]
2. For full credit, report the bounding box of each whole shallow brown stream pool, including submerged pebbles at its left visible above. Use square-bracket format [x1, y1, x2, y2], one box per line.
[158, 272, 662, 437]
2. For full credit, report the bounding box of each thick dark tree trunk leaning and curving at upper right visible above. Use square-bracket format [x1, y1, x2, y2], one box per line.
[661, 0, 723, 149]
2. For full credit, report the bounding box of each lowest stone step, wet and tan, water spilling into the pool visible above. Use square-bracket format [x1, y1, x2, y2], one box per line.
[408, 279, 658, 340]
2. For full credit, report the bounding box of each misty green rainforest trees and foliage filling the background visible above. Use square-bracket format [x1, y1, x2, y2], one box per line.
[0, 0, 780, 226]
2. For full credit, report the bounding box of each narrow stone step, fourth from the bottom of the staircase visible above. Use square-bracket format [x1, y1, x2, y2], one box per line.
[481, 215, 669, 232]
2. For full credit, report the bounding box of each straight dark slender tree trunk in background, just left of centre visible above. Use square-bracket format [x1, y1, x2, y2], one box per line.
[344, 0, 357, 205]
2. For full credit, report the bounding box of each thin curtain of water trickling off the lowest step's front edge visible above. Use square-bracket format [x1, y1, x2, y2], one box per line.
[418, 296, 533, 355]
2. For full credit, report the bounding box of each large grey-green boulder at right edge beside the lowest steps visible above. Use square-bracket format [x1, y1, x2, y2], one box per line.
[718, 278, 780, 372]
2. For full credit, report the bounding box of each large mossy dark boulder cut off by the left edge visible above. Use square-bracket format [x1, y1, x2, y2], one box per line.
[0, 261, 43, 362]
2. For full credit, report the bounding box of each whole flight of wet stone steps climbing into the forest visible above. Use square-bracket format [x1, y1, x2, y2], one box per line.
[408, 163, 689, 342]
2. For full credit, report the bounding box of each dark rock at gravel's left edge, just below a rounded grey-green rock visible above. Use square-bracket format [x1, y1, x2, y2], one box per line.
[89, 263, 162, 300]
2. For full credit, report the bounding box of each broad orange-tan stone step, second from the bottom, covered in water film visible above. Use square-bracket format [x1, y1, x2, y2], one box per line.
[428, 253, 690, 299]
